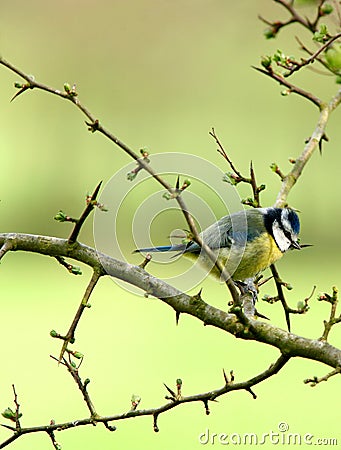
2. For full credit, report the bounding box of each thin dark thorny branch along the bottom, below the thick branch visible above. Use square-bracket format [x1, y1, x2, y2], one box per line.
[0, 355, 290, 449]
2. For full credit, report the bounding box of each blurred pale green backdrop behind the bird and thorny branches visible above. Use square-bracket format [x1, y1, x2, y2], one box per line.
[0, 0, 341, 450]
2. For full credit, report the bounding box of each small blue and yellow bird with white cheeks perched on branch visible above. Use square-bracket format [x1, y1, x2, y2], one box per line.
[135, 207, 301, 281]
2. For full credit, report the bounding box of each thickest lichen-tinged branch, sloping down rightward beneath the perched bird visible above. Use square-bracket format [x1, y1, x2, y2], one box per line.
[0, 233, 341, 368]
